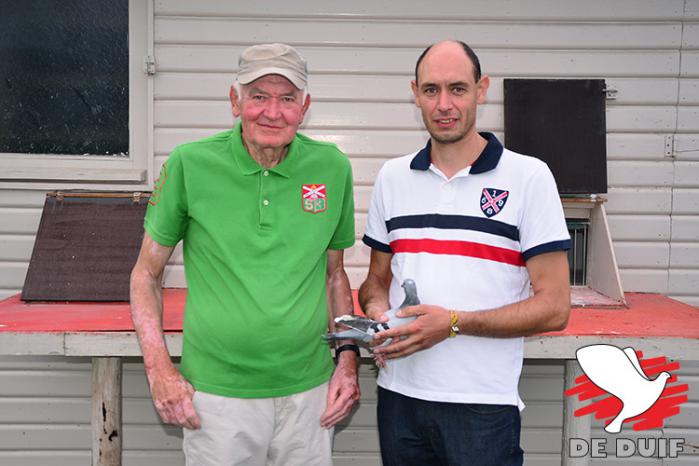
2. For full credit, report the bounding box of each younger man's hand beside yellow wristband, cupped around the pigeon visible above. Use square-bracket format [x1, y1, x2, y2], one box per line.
[371, 304, 450, 359]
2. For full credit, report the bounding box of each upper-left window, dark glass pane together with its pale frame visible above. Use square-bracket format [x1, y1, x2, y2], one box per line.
[0, 0, 148, 182]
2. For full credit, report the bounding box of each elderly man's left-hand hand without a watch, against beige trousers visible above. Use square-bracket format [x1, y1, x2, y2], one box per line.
[148, 366, 201, 429]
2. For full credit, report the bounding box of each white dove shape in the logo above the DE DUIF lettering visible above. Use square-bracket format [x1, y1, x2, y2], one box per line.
[575, 344, 670, 434]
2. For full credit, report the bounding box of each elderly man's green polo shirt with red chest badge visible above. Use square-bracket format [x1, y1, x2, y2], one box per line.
[145, 124, 354, 398]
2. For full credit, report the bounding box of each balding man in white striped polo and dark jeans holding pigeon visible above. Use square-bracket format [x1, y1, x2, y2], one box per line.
[359, 41, 570, 466]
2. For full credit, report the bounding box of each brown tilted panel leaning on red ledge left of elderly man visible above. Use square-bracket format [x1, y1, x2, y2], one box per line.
[22, 193, 148, 301]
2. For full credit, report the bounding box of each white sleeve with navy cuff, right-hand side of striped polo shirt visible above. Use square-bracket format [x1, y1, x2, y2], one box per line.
[519, 163, 570, 261]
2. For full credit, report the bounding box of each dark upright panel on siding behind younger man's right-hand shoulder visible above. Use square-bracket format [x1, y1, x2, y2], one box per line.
[504, 79, 607, 194]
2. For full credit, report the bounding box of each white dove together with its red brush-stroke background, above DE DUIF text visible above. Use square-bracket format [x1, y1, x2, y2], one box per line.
[565, 344, 689, 434]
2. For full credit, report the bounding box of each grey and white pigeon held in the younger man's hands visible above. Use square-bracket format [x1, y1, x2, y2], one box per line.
[323, 278, 420, 344]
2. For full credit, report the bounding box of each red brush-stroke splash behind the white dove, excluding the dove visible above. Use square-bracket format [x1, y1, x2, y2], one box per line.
[565, 351, 689, 430]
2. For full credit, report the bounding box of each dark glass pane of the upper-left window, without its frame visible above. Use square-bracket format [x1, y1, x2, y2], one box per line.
[0, 0, 129, 156]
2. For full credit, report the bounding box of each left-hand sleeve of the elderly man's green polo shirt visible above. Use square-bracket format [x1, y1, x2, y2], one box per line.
[143, 149, 188, 246]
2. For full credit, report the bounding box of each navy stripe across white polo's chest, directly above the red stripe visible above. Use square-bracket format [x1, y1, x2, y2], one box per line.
[386, 214, 519, 241]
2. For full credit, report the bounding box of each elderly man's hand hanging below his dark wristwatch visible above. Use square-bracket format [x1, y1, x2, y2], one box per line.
[320, 351, 360, 429]
